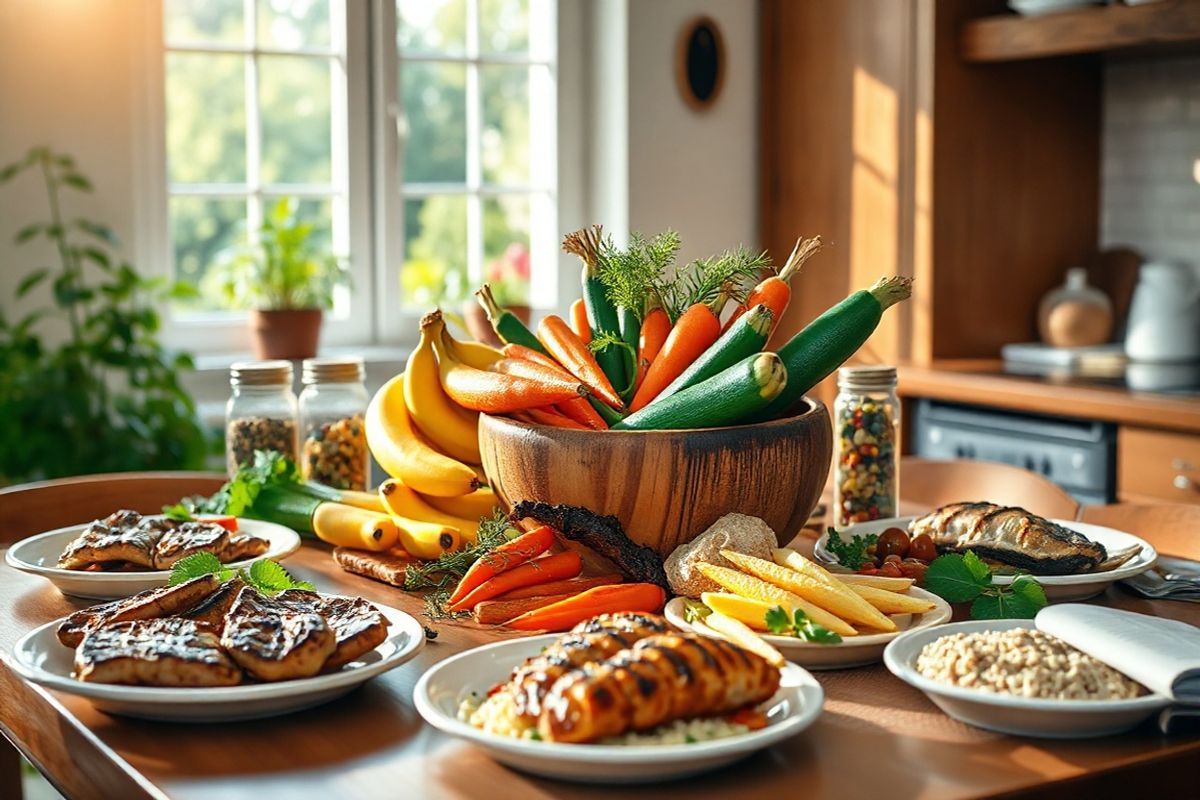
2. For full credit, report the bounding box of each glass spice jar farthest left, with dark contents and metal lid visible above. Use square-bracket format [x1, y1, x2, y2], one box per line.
[226, 361, 298, 476]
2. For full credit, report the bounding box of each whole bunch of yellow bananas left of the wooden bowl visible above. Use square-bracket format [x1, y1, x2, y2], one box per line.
[366, 315, 500, 559]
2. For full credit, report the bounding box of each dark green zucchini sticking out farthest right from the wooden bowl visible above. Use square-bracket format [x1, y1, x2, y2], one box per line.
[754, 276, 912, 421]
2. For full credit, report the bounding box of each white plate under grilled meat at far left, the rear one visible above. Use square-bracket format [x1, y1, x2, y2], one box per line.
[5, 517, 300, 600]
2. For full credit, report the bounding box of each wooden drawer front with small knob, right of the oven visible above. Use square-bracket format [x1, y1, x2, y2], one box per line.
[1117, 426, 1200, 504]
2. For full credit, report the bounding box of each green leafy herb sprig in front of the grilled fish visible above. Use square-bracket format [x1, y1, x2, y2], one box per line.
[925, 551, 1046, 619]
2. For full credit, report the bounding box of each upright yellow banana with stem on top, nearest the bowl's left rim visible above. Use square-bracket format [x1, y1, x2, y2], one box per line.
[404, 314, 479, 464]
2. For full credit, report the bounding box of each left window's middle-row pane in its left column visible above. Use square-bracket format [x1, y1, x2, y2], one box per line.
[166, 53, 246, 184]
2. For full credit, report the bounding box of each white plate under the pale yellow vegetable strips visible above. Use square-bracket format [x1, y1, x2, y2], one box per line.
[665, 587, 953, 669]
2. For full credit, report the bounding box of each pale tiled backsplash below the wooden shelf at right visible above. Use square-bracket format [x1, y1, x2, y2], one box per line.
[1100, 58, 1200, 264]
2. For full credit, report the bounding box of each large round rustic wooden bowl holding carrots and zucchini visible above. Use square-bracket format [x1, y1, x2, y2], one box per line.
[479, 398, 833, 558]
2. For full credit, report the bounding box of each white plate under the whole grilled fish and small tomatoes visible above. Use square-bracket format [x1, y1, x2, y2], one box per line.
[812, 517, 1158, 602]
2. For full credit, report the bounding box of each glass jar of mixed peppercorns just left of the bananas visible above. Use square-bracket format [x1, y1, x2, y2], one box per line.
[300, 359, 371, 492]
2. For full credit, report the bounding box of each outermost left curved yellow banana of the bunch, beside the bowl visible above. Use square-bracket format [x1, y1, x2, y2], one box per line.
[365, 374, 479, 498]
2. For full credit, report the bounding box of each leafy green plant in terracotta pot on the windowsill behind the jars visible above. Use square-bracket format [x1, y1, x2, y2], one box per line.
[217, 198, 349, 359]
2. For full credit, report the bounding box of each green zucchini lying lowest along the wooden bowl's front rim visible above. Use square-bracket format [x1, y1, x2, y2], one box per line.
[612, 353, 787, 431]
